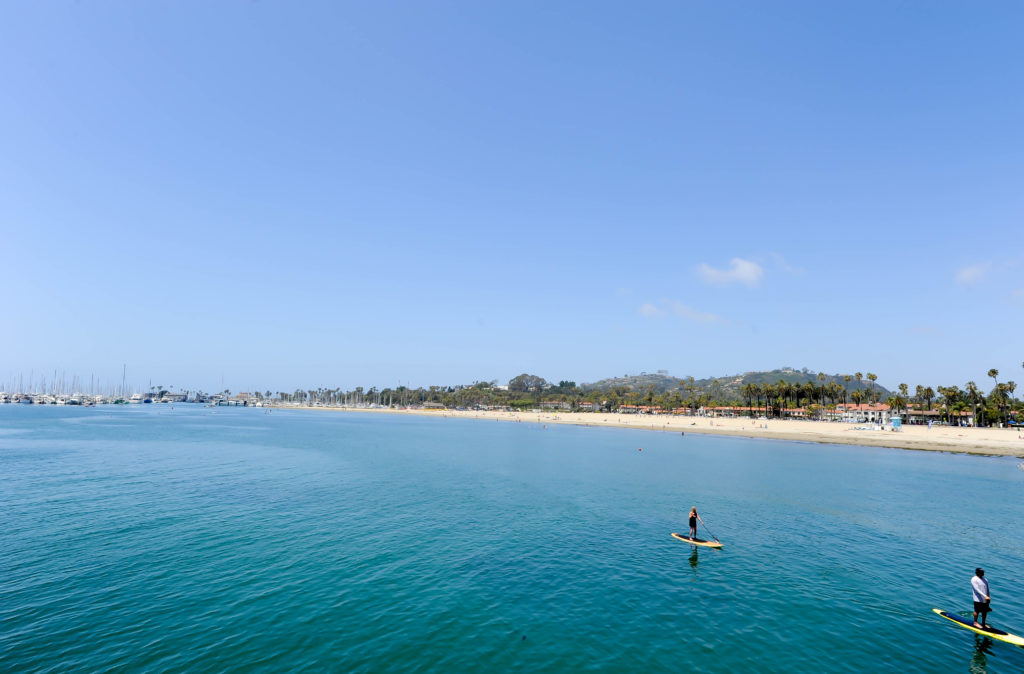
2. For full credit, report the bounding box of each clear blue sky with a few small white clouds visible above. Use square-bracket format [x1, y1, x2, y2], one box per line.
[0, 1, 1024, 390]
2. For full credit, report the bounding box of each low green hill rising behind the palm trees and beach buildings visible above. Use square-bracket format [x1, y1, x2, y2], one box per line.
[581, 368, 891, 399]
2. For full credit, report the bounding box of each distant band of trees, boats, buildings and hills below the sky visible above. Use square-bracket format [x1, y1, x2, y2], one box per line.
[0, 368, 1024, 426]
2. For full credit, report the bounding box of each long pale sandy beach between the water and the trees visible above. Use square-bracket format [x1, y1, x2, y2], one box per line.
[278, 406, 1024, 458]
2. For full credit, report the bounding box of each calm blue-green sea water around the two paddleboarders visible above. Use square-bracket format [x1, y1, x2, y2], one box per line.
[0, 405, 1024, 672]
